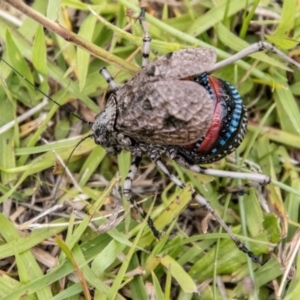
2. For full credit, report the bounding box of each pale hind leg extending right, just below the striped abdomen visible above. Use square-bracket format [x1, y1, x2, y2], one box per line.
[166, 149, 271, 187]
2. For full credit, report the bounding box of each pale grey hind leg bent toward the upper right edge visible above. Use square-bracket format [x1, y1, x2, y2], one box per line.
[206, 41, 300, 74]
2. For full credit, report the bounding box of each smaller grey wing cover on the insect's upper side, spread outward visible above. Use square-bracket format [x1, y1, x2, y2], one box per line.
[127, 48, 216, 85]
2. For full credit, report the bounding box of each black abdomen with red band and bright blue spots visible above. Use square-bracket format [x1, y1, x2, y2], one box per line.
[179, 73, 247, 163]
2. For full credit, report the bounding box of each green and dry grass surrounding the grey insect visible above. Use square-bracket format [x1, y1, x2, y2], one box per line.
[0, 0, 300, 299]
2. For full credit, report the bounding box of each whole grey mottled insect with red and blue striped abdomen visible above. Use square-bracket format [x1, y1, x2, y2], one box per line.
[2, 8, 300, 262]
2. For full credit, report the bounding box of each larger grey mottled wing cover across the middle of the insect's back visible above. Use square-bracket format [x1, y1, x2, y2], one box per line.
[115, 80, 213, 145]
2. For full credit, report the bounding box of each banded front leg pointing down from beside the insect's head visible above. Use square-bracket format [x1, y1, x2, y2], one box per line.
[123, 154, 161, 239]
